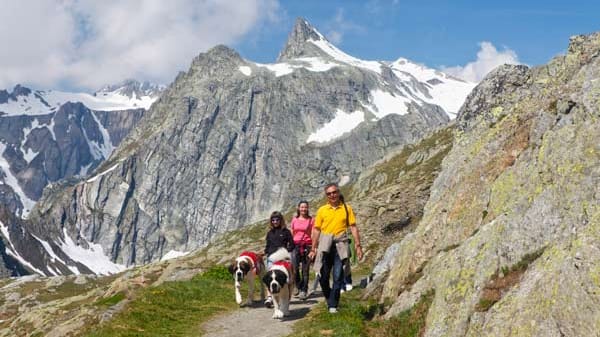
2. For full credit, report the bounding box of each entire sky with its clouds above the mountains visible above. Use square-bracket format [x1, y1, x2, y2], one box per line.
[0, 0, 600, 91]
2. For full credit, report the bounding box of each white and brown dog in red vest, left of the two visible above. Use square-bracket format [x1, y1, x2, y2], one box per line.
[229, 252, 265, 305]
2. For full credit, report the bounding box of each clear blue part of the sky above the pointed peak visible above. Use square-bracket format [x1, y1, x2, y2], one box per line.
[236, 0, 600, 68]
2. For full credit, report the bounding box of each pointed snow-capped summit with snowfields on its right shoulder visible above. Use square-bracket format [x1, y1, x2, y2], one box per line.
[270, 18, 476, 124]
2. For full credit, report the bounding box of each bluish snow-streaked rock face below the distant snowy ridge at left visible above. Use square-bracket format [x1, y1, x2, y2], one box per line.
[0, 101, 144, 215]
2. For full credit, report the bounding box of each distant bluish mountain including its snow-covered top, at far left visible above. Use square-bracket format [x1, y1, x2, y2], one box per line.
[0, 80, 164, 216]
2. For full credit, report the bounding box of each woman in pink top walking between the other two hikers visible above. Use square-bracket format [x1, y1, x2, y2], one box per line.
[290, 200, 315, 300]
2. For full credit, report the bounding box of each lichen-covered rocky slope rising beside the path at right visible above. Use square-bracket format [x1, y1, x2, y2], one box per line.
[382, 33, 600, 336]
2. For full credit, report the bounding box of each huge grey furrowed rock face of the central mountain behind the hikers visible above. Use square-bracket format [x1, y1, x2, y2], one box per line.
[22, 17, 448, 265]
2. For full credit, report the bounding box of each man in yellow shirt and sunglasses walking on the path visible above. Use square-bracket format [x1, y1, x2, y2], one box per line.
[309, 184, 363, 313]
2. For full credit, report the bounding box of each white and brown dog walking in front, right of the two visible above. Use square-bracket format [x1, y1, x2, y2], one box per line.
[262, 248, 294, 318]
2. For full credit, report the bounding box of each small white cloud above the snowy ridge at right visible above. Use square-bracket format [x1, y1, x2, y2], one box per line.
[442, 41, 521, 82]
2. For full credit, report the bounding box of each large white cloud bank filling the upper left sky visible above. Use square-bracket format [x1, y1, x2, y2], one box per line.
[0, 0, 280, 90]
